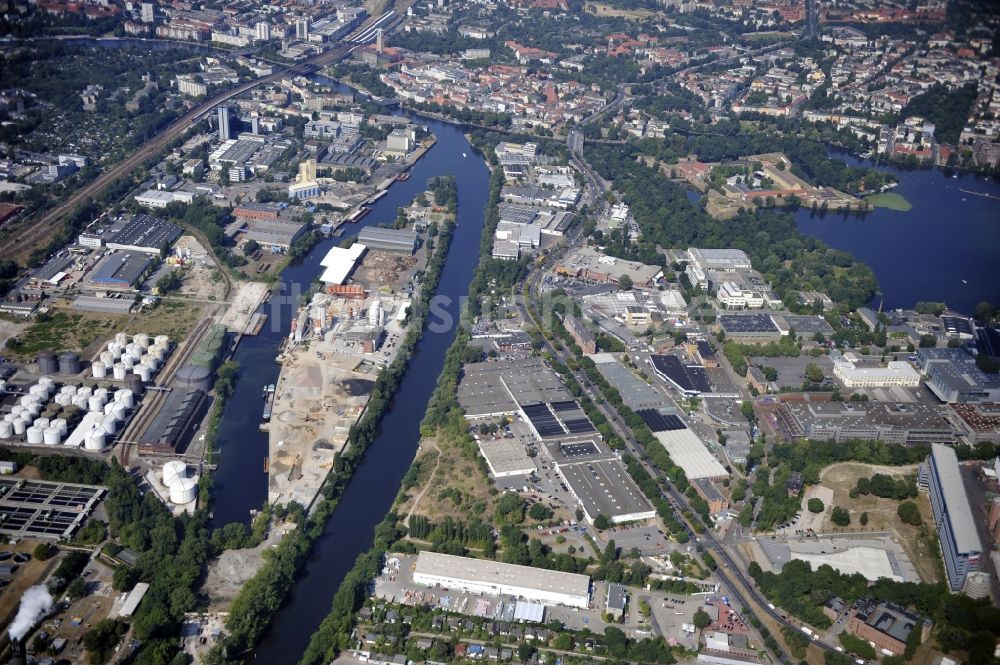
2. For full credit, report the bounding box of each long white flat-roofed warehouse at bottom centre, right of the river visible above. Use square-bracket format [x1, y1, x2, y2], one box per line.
[413, 552, 590, 608]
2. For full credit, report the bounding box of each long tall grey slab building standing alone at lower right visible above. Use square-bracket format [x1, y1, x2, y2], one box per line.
[920, 443, 983, 591]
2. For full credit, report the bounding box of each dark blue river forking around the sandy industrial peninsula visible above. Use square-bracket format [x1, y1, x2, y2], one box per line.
[213, 81, 489, 663]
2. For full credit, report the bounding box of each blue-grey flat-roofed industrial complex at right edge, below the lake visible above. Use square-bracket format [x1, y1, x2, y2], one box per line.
[916, 347, 1000, 402]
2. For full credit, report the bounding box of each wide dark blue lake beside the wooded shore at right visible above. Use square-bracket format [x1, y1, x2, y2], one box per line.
[795, 161, 1000, 314]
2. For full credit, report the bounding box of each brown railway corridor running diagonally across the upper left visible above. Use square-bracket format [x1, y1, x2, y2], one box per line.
[0, 10, 397, 257]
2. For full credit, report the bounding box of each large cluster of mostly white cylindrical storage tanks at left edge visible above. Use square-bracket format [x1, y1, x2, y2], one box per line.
[0, 333, 171, 453]
